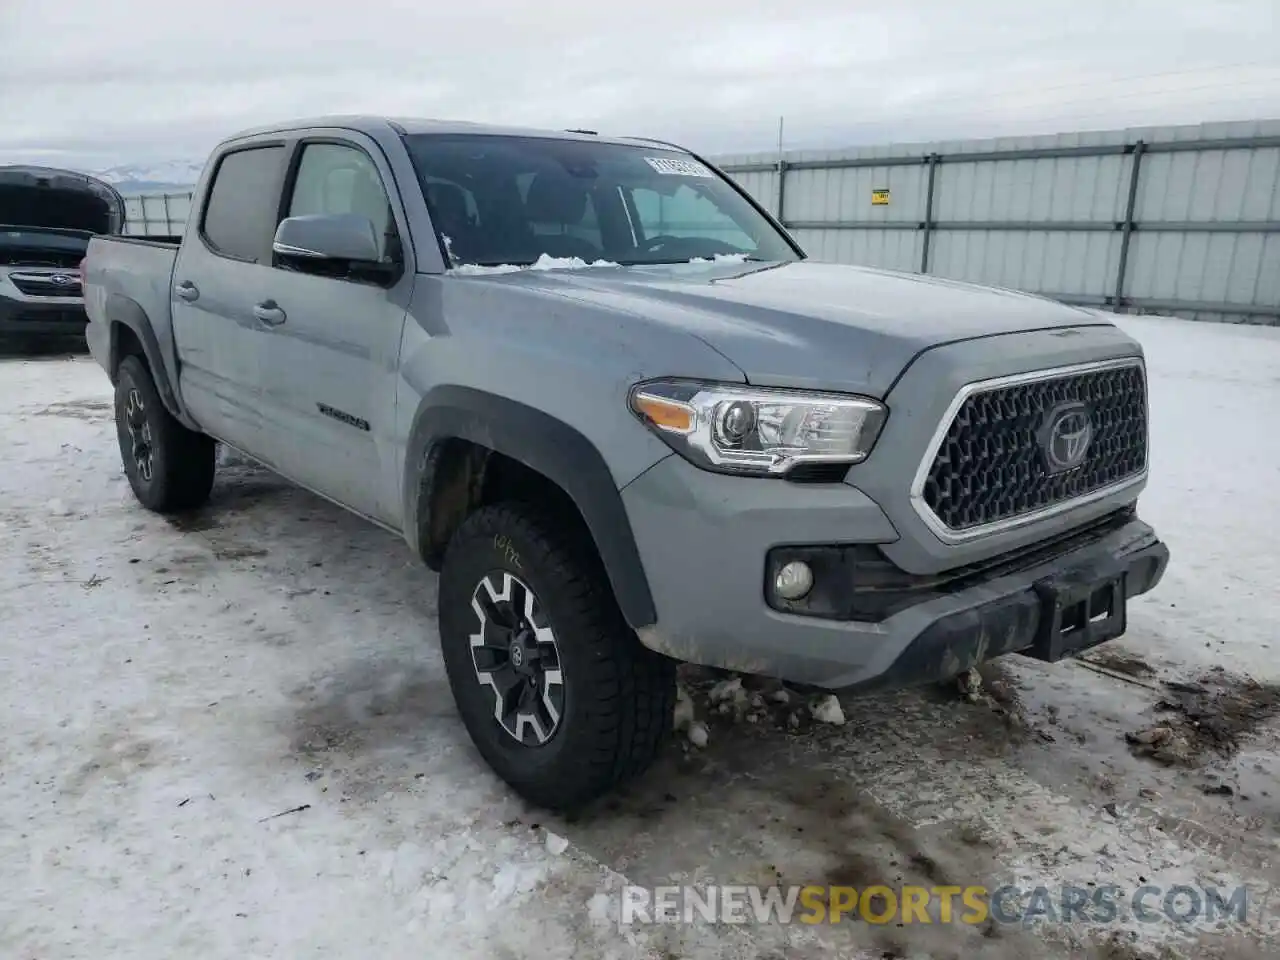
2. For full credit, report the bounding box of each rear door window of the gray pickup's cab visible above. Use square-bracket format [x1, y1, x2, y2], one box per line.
[201, 146, 284, 264]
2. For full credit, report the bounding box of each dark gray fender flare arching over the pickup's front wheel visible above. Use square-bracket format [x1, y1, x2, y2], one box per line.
[403, 385, 658, 630]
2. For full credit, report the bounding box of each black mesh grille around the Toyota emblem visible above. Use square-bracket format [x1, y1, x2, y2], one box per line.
[924, 366, 1147, 530]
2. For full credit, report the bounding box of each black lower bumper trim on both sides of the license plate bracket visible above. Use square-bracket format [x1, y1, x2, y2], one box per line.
[849, 540, 1169, 692]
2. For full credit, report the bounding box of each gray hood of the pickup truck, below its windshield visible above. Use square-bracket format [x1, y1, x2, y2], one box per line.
[468, 260, 1108, 398]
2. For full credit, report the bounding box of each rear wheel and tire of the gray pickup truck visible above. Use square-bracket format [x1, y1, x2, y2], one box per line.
[115, 356, 216, 513]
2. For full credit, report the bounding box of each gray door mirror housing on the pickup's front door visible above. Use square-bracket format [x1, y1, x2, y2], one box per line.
[271, 214, 397, 280]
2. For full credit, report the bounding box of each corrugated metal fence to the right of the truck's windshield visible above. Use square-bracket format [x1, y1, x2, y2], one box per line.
[716, 120, 1280, 324]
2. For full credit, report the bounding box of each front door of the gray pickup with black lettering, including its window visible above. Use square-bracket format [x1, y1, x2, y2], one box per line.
[262, 131, 413, 527]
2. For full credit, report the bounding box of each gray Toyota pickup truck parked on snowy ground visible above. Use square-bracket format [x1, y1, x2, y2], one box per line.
[84, 118, 1169, 809]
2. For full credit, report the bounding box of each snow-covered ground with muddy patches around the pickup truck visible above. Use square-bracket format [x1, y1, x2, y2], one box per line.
[0, 319, 1280, 960]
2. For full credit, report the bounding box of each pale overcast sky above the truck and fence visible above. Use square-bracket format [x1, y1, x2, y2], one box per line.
[0, 0, 1280, 169]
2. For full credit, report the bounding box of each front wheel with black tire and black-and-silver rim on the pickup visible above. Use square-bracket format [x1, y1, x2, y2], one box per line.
[439, 503, 676, 810]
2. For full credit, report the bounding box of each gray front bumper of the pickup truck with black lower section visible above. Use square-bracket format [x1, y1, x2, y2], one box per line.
[622, 457, 1169, 690]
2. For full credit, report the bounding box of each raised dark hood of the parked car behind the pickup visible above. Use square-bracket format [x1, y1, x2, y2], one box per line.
[0, 166, 124, 233]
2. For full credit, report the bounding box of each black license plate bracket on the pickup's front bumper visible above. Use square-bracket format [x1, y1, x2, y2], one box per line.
[1027, 572, 1128, 663]
